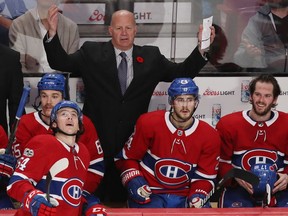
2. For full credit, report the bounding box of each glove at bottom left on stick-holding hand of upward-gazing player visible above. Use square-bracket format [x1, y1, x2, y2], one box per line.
[23, 190, 59, 216]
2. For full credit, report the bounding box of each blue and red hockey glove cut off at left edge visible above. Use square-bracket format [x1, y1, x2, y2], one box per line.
[0, 150, 17, 178]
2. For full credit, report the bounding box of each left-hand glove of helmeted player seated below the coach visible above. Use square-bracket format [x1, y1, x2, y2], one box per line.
[121, 169, 152, 204]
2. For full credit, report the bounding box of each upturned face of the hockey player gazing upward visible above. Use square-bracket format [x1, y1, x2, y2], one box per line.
[57, 107, 79, 134]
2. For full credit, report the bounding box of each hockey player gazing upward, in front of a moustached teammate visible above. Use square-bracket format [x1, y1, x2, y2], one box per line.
[7, 101, 106, 216]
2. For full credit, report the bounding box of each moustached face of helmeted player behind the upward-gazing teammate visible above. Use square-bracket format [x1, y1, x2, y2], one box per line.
[40, 90, 63, 117]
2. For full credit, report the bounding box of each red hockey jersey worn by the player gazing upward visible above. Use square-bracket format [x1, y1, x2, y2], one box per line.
[7, 134, 90, 216]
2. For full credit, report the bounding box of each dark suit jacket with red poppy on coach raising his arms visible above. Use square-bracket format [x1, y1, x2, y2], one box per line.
[44, 35, 206, 159]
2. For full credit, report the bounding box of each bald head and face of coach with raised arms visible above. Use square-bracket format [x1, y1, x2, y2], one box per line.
[109, 11, 137, 51]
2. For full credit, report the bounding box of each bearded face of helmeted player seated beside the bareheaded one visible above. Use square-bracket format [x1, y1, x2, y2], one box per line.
[173, 95, 198, 121]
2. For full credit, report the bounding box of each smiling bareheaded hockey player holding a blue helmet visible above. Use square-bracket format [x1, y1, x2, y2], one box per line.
[216, 74, 288, 207]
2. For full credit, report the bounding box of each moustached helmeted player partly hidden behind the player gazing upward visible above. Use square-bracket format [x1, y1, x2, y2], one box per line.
[13, 73, 104, 199]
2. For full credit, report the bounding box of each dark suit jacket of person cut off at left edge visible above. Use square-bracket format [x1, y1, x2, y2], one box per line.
[0, 44, 23, 132]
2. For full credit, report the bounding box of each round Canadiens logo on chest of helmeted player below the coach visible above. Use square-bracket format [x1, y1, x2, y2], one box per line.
[155, 159, 191, 187]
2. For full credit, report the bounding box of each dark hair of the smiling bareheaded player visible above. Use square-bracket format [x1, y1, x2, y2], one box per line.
[249, 74, 281, 107]
